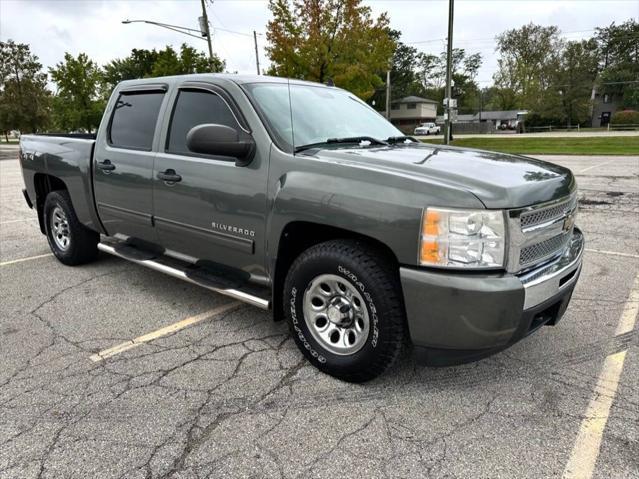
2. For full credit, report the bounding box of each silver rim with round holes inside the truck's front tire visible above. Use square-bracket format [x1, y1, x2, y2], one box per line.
[303, 274, 370, 356]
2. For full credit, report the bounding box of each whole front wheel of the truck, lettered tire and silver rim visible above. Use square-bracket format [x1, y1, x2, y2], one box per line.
[284, 240, 405, 382]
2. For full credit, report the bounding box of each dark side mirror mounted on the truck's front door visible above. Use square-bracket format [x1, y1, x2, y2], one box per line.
[186, 123, 255, 166]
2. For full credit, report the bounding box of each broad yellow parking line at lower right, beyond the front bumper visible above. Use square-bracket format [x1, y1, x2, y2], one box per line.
[563, 274, 639, 479]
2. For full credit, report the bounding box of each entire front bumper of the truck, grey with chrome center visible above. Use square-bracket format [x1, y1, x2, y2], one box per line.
[400, 228, 584, 357]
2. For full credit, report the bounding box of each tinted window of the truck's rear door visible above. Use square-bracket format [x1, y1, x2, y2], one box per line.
[109, 92, 164, 150]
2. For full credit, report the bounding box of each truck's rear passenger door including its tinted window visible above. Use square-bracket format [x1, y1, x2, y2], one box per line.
[93, 85, 166, 243]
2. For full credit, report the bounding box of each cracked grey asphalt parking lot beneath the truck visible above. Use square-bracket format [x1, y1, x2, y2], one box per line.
[0, 147, 639, 479]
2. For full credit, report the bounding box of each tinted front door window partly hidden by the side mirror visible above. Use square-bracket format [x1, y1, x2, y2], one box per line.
[166, 90, 238, 154]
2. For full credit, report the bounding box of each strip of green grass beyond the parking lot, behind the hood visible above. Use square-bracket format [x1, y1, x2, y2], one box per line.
[423, 135, 639, 156]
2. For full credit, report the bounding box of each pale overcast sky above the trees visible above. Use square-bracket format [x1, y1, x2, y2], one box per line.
[0, 0, 639, 86]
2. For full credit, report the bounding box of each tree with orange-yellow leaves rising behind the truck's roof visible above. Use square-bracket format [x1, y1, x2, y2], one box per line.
[266, 0, 395, 99]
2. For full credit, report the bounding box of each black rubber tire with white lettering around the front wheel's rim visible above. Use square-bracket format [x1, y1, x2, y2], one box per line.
[283, 240, 405, 382]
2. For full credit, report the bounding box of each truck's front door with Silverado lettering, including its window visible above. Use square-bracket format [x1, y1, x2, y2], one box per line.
[153, 82, 269, 277]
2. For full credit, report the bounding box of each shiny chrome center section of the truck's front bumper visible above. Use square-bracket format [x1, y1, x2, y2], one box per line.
[519, 228, 584, 309]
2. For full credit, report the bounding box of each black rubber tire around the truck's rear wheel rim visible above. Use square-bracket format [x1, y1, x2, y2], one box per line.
[44, 190, 100, 266]
